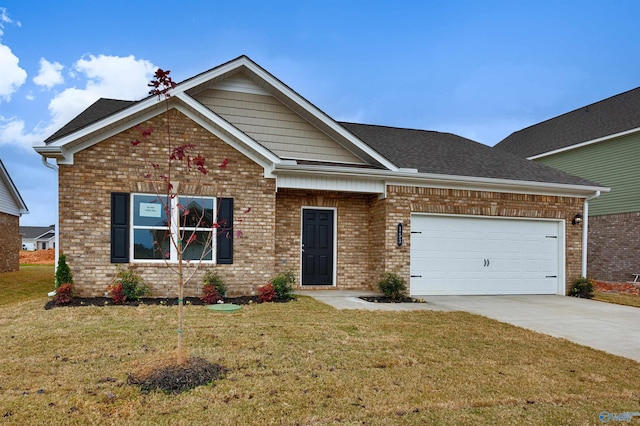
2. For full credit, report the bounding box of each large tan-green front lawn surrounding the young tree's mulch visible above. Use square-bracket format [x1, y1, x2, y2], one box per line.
[0, 297, 640, 425]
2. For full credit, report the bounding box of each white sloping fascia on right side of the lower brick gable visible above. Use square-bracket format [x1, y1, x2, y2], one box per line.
[174, 93, 281, 167]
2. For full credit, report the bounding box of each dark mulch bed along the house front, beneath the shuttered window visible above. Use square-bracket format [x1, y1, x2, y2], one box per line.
[44, 296, 295, 310]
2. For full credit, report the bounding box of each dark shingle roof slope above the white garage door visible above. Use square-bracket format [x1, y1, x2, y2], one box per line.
[340, 123, 597, 186]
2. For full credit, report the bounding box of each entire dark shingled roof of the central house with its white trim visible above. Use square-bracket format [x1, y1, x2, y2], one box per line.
[34, 56, 607, 198]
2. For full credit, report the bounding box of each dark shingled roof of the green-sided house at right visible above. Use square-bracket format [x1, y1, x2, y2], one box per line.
[494, 87, 640, 158]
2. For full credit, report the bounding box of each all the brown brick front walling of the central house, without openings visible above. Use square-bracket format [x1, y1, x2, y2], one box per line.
[55, 110, 582, 297]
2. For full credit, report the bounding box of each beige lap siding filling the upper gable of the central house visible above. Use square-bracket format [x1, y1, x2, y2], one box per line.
[195, 89, 364, 164]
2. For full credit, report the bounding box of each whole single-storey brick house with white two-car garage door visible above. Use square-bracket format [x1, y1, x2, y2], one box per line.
[35, 56, 607, 296]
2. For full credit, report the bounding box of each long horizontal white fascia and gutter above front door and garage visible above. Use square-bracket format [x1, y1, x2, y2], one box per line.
[273, 165, 611, 197]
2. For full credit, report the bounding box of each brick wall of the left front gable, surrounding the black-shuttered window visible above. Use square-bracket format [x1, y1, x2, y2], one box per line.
[59, 110, 276, 297]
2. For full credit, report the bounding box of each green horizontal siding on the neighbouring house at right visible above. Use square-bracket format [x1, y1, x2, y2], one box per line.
[535, 133, 640, 216]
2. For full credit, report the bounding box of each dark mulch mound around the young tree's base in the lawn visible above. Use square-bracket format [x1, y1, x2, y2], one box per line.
[128, 357, 228, 394]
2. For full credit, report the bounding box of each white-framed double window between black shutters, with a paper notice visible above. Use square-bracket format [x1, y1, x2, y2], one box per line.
[131, 194, 216, 262]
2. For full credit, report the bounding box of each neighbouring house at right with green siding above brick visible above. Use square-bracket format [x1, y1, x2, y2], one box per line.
[495, 88, 640, 282]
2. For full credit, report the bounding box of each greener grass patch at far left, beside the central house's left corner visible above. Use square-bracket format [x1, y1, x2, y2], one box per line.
[0, 265, 54, 306]
